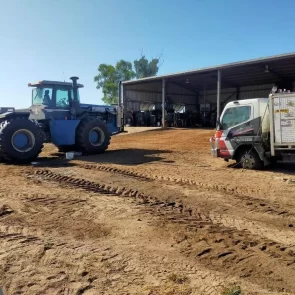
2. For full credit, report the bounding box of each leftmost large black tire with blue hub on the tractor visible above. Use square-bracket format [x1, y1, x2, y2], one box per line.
[0, 118, 43, 162]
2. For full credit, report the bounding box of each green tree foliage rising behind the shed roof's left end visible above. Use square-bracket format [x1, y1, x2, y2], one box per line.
[94, 54, 160, 104]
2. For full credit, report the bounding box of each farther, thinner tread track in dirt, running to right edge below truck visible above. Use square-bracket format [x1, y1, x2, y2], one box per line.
[79, 164, 294, 217]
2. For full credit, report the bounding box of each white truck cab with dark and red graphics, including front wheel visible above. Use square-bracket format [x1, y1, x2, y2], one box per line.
[210, 98, 269, 169]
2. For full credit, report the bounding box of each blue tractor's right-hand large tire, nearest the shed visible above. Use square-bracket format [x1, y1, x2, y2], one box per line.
[76, 118, 111, 154]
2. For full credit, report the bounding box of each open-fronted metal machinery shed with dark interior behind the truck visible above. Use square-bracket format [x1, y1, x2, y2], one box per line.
[120, 53, 295, 127]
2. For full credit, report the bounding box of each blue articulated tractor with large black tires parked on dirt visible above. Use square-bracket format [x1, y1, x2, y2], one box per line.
[0, 77, 124, 162]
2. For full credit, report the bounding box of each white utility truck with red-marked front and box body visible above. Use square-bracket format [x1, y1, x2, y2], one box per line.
[210, 92, 295, 169]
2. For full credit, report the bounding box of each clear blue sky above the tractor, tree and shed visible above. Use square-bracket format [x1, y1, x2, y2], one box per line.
[0, 0, 295, 107]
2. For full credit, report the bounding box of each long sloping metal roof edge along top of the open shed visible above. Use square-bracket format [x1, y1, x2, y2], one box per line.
[122, 52, 295, 84]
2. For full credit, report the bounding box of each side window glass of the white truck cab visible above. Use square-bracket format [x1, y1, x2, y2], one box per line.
[221, 106, 251, 130]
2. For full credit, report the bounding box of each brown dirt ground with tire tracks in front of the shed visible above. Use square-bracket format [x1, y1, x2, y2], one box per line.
[0, 129, 295, 295]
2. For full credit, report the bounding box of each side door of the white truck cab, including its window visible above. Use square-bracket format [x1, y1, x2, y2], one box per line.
[219, 104, 255, 159]
